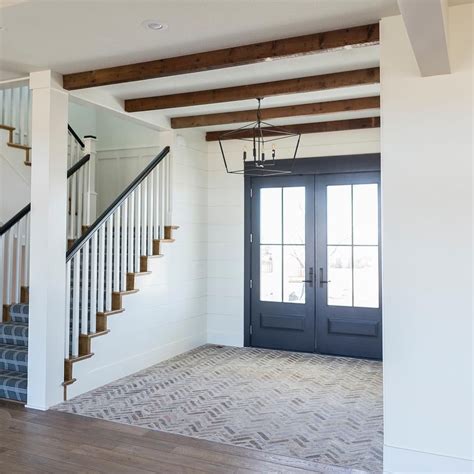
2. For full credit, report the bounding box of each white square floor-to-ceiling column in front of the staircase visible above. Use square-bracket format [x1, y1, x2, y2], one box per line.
[27, 71, 68, 410]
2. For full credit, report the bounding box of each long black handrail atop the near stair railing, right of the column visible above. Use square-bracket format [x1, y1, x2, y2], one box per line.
[66, 146, 170, 263]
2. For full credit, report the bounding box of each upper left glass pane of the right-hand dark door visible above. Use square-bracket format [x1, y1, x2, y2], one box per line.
[327, 185, 352, 245]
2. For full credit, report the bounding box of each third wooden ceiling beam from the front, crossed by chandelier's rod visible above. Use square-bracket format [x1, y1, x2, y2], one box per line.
[171, 96, 380, 128]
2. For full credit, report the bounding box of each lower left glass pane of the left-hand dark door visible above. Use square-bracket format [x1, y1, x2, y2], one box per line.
[260, 245, 282, 302]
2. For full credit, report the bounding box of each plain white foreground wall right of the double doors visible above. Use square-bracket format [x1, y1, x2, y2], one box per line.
[381, 5, 474, 472]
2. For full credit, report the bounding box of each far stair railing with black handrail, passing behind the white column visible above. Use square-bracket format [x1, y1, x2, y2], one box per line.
[0, 155, 90, 312]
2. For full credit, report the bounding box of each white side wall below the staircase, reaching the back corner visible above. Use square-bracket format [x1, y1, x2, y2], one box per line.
[68, 132, 207, 397]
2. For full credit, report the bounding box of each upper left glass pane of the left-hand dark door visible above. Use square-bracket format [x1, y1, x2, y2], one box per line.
[260, 188, 282, 244]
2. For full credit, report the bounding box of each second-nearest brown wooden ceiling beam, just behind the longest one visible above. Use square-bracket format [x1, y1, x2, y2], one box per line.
[125, 67, 380, 112]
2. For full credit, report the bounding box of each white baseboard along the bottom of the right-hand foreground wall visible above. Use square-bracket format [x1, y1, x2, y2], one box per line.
[383, 445, 474, 474]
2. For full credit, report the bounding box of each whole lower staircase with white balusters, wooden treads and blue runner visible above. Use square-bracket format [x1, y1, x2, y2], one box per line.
[0, 120, 174, 403]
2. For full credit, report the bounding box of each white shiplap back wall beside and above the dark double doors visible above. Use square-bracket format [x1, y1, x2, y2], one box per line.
[207, 129, 380, 346]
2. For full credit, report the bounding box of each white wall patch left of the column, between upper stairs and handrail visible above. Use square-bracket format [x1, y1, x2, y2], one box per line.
[0, 130, 31, 224]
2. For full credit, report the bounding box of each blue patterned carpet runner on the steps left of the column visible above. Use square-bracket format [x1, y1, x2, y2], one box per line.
[0, 304, 29, 403]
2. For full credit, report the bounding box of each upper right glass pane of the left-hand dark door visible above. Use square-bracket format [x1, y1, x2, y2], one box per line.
[283, 187, 305, 244]
